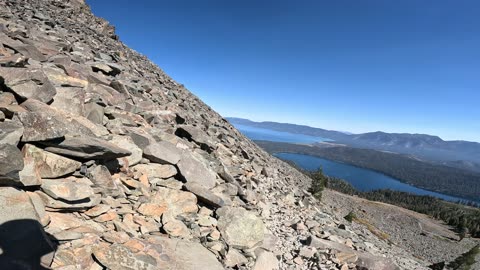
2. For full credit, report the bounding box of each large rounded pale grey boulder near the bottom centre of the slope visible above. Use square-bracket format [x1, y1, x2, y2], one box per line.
[217, 206, 265, 249]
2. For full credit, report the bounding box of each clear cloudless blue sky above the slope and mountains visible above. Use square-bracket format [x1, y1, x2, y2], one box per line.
[87, 0, 480, 141]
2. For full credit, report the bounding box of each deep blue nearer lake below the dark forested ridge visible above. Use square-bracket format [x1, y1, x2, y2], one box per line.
[275, 153, 478, 202]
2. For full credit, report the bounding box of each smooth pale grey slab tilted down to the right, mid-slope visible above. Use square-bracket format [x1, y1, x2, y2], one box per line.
[177, 152, 217, 189]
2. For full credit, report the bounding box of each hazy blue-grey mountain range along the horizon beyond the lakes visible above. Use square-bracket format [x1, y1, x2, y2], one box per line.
[227, 118, 480, 171]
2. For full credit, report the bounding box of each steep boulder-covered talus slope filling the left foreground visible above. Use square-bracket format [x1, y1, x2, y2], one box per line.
[0, 0, 434, 270]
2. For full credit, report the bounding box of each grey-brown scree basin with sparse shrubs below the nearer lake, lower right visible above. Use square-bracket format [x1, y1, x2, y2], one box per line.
[322, 190, 480, 269]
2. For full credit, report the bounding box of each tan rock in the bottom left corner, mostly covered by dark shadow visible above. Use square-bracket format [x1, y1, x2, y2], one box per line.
[0, 187, 55, 269]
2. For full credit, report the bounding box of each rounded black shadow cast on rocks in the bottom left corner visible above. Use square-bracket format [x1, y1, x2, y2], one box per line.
[0, 219, 56, 270]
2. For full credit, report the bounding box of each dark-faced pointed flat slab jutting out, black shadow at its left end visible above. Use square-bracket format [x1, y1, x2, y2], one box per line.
[41, 136, 132, 160]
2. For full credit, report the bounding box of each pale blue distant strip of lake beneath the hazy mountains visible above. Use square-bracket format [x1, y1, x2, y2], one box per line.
[234, 124, 330, 143]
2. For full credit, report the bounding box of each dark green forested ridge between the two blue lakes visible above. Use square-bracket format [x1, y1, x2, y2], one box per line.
[256, 141, 480, 200]
